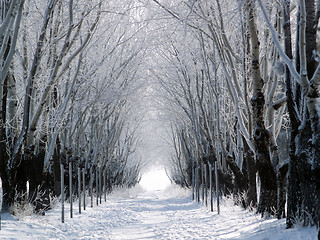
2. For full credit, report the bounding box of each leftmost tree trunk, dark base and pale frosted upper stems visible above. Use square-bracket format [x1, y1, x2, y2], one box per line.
[0, 0, 26, 210]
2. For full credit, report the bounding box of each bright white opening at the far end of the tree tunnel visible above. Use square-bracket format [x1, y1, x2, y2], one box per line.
[140, 167, 171, 191]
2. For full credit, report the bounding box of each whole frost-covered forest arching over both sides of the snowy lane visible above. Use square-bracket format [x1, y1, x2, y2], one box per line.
[0, 0, 320, 232]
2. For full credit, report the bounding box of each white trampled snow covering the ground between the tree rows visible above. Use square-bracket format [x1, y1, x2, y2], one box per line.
[0, 186, 317, 240]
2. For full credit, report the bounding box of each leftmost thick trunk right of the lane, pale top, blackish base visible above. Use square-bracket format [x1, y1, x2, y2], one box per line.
[247, 1, 277, 215]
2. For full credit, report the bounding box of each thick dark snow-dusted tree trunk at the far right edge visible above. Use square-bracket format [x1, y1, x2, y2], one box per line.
[303, 0, 320, 226]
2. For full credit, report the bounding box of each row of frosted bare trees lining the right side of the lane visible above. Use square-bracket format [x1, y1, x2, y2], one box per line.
[153, 0, 320, 227]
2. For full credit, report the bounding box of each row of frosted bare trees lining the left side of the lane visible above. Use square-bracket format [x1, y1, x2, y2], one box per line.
[0, 0, 145, 213]
